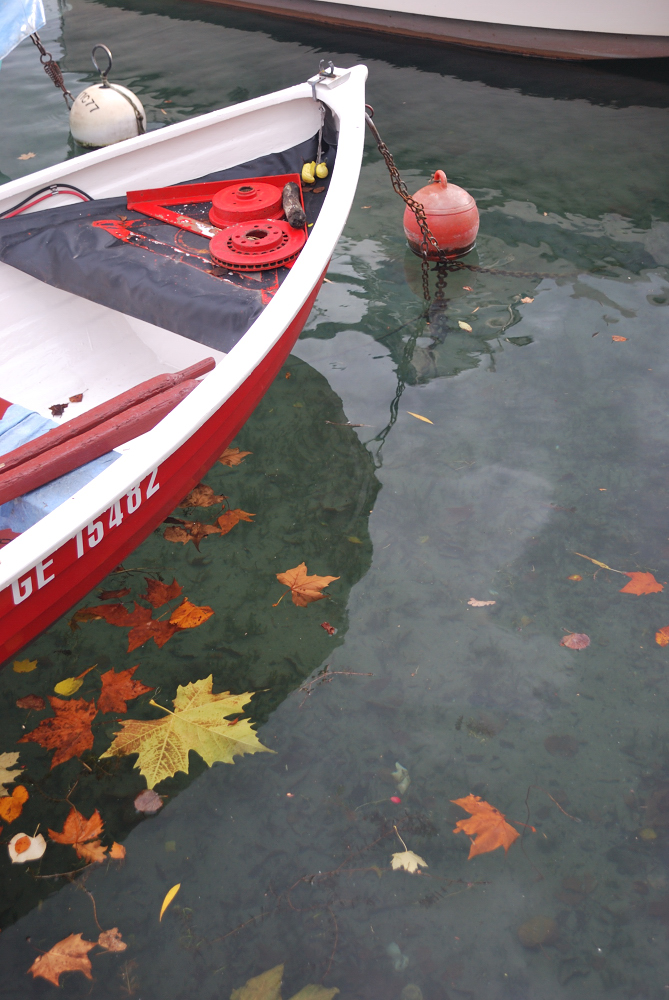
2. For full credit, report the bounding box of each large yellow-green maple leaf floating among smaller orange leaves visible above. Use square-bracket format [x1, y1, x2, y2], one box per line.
[102, 674, 274, 788]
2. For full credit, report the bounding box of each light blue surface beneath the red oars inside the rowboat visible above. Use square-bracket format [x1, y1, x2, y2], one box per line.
[0, 402, 120, 532]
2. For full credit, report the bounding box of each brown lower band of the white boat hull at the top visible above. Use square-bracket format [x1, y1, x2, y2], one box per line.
[187, 0, 669, 60]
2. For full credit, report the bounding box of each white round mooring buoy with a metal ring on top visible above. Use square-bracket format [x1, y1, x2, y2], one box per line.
[70, 45, 146, 148]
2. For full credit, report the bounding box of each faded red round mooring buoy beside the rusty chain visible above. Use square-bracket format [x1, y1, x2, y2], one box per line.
[404, 170, 479, 260]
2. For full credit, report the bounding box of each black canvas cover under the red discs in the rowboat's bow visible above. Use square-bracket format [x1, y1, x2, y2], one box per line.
[0, 136, 335, 351]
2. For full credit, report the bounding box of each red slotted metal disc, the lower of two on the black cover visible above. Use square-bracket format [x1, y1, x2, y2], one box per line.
[209, 219, 307, 271]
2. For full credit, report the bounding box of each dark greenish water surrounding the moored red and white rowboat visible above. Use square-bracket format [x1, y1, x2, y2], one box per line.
[0, 0, 669, 1000]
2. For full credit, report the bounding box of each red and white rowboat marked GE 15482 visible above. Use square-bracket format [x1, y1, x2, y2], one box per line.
[0, 60, 367, 662]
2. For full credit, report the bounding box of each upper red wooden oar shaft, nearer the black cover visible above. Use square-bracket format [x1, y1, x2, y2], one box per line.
[0, 358, 216, 474]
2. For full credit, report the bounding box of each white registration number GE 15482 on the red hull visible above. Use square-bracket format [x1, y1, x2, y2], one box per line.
[11, 469, 160, 606]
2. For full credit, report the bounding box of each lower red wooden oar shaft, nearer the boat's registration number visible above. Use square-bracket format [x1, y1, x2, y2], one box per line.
[0, 373, 199, 504]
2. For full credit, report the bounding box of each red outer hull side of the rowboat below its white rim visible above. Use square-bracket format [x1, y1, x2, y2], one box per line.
[0, 278, 322, 663]
